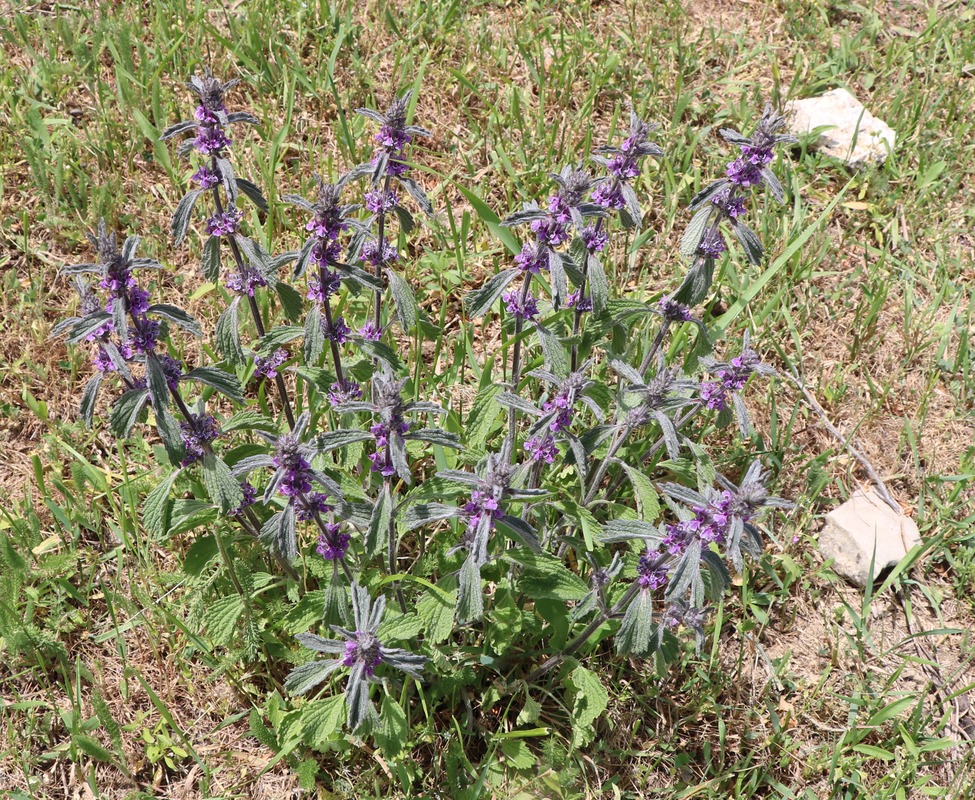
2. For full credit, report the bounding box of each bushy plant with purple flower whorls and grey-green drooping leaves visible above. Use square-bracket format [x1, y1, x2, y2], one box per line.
[56, 74, 790, 756]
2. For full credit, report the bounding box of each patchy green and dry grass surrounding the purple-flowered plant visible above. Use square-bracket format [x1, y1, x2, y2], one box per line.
[0, 0, 975, 800]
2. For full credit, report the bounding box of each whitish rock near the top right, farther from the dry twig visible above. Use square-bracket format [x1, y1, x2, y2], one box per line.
[785, 89, 897, 167]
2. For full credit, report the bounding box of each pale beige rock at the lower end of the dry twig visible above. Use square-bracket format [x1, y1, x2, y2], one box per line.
[819, 489, 921, 589]
